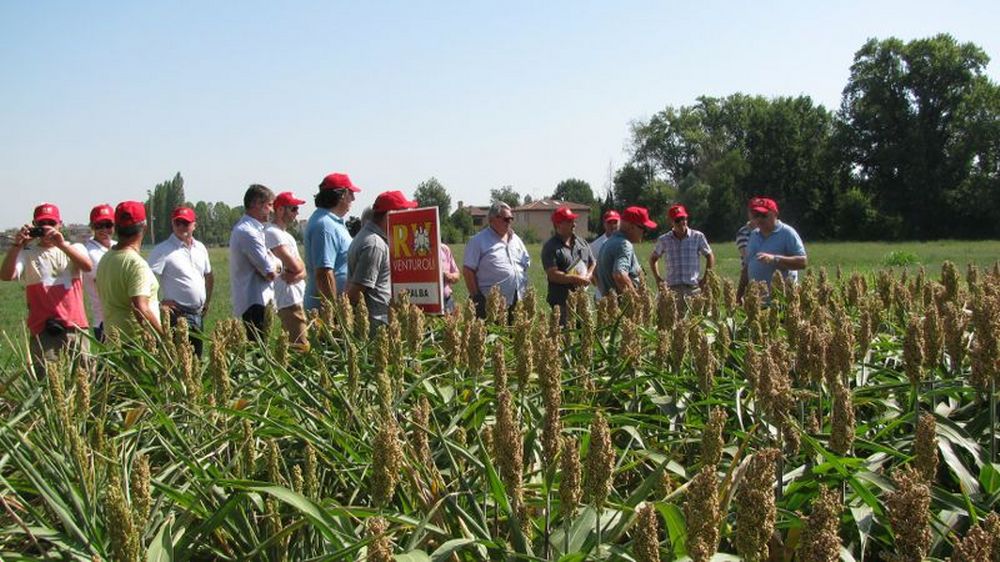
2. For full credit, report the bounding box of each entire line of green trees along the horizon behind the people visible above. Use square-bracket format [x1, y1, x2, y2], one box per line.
[148, 34, 1000, 244]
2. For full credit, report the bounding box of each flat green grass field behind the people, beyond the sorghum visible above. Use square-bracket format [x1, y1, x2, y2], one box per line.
[0, 236, 1000, 347]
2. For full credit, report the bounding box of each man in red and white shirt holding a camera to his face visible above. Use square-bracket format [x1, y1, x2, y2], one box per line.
[0, 203, 93, 377]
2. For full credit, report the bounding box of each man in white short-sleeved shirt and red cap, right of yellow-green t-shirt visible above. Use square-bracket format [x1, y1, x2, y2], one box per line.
[147, 207, 215, 357]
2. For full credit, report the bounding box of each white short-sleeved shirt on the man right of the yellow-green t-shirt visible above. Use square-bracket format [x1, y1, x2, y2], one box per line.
[146, 234, 212, 311]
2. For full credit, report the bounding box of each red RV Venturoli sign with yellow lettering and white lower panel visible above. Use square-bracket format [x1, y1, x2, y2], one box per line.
[386, 207, 444, 314]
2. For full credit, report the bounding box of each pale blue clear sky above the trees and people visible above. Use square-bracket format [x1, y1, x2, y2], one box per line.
[0, 0, 1000, 228]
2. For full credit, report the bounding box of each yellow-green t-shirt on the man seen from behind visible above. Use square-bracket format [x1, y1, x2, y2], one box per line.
[97, 250, 160, 336]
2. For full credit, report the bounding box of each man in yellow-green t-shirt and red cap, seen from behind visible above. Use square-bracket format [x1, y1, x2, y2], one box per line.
[97, 201, 163, 339]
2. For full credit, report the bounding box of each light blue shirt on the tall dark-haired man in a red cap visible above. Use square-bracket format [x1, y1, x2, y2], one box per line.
[302, 209, 351, 309]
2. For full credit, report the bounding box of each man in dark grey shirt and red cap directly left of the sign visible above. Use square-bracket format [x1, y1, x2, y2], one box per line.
[347, 191, 417, 328]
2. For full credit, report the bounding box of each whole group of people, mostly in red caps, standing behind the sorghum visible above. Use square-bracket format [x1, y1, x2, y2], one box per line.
[0, 173, 807, 373]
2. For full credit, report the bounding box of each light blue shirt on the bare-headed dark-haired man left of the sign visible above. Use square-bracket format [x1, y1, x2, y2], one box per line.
[229, 215, 279, 317]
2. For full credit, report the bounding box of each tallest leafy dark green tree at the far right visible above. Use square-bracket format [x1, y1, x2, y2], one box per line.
[840, 35, 1000, 238]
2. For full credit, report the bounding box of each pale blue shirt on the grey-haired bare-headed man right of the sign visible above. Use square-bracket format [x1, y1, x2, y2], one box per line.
[462, 226, 531, 306]
